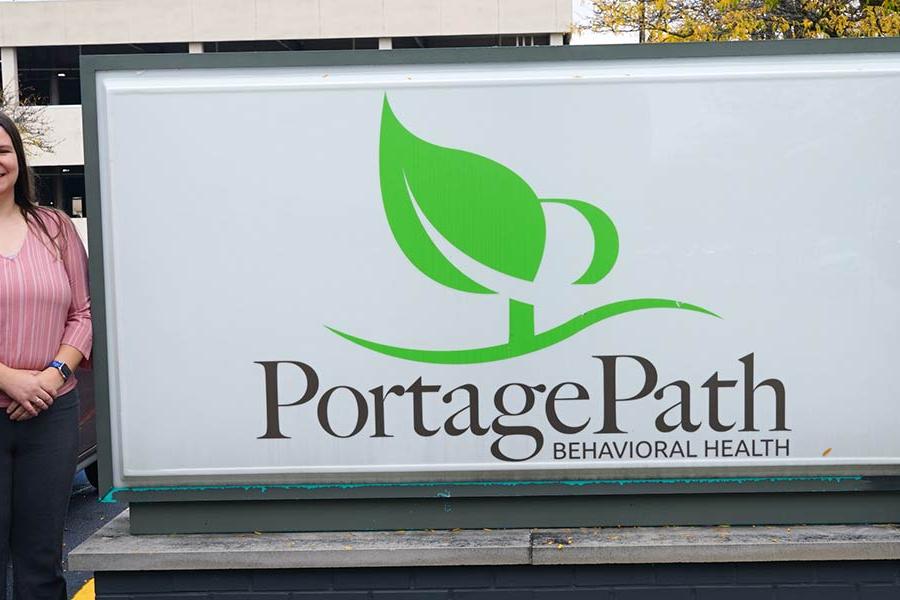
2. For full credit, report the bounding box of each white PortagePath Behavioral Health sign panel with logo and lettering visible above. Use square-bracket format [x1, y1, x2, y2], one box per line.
[96, 48, 900, 486]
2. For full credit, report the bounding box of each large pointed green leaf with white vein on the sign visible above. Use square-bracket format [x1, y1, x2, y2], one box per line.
[380, 96, 546, 294]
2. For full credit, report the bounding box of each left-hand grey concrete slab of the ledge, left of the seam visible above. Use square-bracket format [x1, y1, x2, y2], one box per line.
[69, 511, 531, 571]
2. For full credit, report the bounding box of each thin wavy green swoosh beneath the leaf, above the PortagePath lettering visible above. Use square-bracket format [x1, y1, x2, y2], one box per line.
[326, 298, 721, 365]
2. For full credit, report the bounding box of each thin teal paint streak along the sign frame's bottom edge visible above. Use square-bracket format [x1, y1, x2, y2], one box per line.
[95, 475, 862, 503]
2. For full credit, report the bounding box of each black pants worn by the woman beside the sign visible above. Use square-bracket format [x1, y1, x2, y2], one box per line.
[0, 390, 78, 600]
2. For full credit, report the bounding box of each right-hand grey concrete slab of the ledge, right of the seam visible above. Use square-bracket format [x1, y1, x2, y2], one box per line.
[532, 525, 900, 565]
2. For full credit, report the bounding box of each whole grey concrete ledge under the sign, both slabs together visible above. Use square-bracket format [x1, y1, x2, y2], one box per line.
[69, 511, 900, 571]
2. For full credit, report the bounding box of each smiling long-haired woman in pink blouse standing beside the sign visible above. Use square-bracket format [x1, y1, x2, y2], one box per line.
[0, 113, 92, 600]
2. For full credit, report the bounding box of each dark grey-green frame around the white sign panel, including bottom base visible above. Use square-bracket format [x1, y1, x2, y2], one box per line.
[81, 38, 900, 533]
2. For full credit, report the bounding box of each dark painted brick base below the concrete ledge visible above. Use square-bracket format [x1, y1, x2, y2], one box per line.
[96, 561, 900, 600]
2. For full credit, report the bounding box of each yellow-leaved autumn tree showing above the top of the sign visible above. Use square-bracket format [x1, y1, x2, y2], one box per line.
[589, 0, 900, 42]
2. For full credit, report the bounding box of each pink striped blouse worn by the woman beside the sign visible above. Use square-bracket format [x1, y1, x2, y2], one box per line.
[0, 209, 92, 408]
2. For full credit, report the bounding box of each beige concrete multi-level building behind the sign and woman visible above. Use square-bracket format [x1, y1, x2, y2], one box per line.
[0, 0, 572, 216]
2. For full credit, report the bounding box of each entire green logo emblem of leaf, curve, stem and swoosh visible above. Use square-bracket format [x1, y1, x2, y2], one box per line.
[329, 96, 718, 364]
